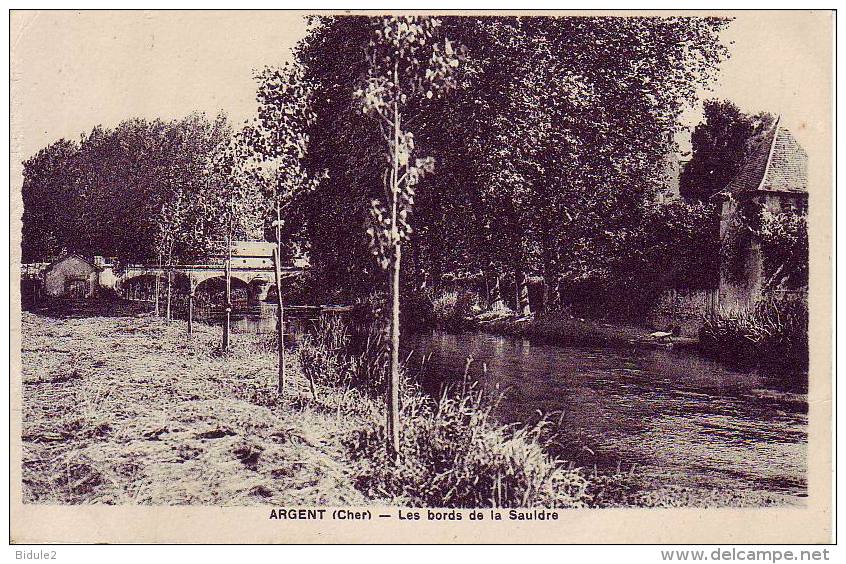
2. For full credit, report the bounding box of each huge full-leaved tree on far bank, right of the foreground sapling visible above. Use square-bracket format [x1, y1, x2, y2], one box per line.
[432, 17, 728, 313]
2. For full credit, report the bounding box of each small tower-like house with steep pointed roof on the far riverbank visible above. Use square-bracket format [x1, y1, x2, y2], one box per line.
[712, 118, 808, 310]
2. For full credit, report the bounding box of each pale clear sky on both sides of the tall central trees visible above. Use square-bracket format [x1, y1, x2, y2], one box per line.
[11, 11, 831, 162]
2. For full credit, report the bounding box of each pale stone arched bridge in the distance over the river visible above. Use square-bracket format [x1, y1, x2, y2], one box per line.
[114, 264, 306, 303]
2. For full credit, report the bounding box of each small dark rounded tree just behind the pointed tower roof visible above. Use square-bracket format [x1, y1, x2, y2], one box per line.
[679, 100, 774, 201]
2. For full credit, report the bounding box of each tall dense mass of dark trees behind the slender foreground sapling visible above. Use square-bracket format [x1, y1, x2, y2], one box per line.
[282, 17, 728, 312]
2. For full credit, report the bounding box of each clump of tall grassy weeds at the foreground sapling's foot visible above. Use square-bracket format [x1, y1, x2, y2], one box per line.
[349, 386, 587, 508]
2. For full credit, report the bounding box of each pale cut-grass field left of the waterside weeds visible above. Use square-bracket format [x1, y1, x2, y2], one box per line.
[22, 313, 376, 505]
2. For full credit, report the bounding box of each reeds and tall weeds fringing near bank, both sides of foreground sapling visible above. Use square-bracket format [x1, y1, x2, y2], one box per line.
[297, 317, 587, 507]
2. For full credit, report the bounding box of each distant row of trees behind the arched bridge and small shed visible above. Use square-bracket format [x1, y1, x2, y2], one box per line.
[22, 113, 264, 264]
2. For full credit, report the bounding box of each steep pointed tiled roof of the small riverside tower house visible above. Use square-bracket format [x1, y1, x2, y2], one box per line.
[721, 119, 808, 193]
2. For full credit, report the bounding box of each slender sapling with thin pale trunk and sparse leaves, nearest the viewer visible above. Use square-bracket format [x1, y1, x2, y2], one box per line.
[356, 17, 468, 458]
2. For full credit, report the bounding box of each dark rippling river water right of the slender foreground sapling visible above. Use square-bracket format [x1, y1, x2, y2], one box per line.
[405, 331, 808, 497]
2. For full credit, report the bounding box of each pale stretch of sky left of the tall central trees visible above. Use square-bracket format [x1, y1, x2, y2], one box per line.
[11, 11, 306, 158]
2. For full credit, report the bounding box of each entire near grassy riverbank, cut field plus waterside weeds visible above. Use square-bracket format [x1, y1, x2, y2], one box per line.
[22, 313, 790, 507]
